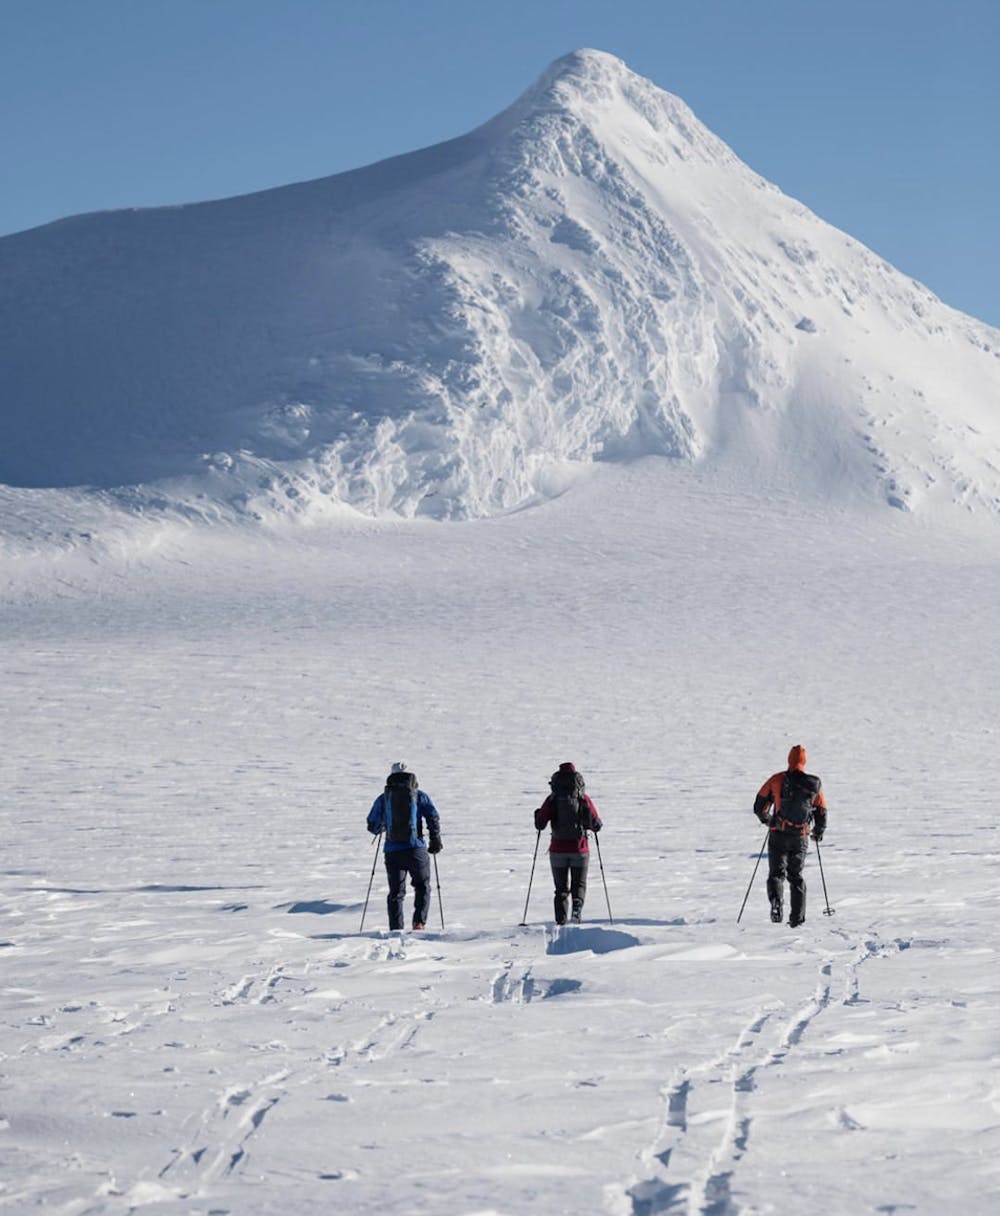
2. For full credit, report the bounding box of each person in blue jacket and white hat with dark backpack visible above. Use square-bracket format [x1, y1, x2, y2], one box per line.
[367, 760, 443, 930]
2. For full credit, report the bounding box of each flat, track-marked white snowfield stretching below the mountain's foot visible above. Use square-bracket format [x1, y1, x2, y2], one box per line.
[0, 460, 1000, 1216]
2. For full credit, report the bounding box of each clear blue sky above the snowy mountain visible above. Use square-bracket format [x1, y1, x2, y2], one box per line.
[0, 0, 1000, 325]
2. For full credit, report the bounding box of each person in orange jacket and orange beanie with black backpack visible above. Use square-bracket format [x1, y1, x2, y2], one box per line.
[753, 743, 826, 929]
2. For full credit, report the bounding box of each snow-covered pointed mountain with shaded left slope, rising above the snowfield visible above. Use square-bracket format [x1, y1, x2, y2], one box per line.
[0, 51, 1000, 518]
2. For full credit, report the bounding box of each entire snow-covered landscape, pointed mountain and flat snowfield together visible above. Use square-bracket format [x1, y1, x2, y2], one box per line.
[0, 40, 1000, 1216]
